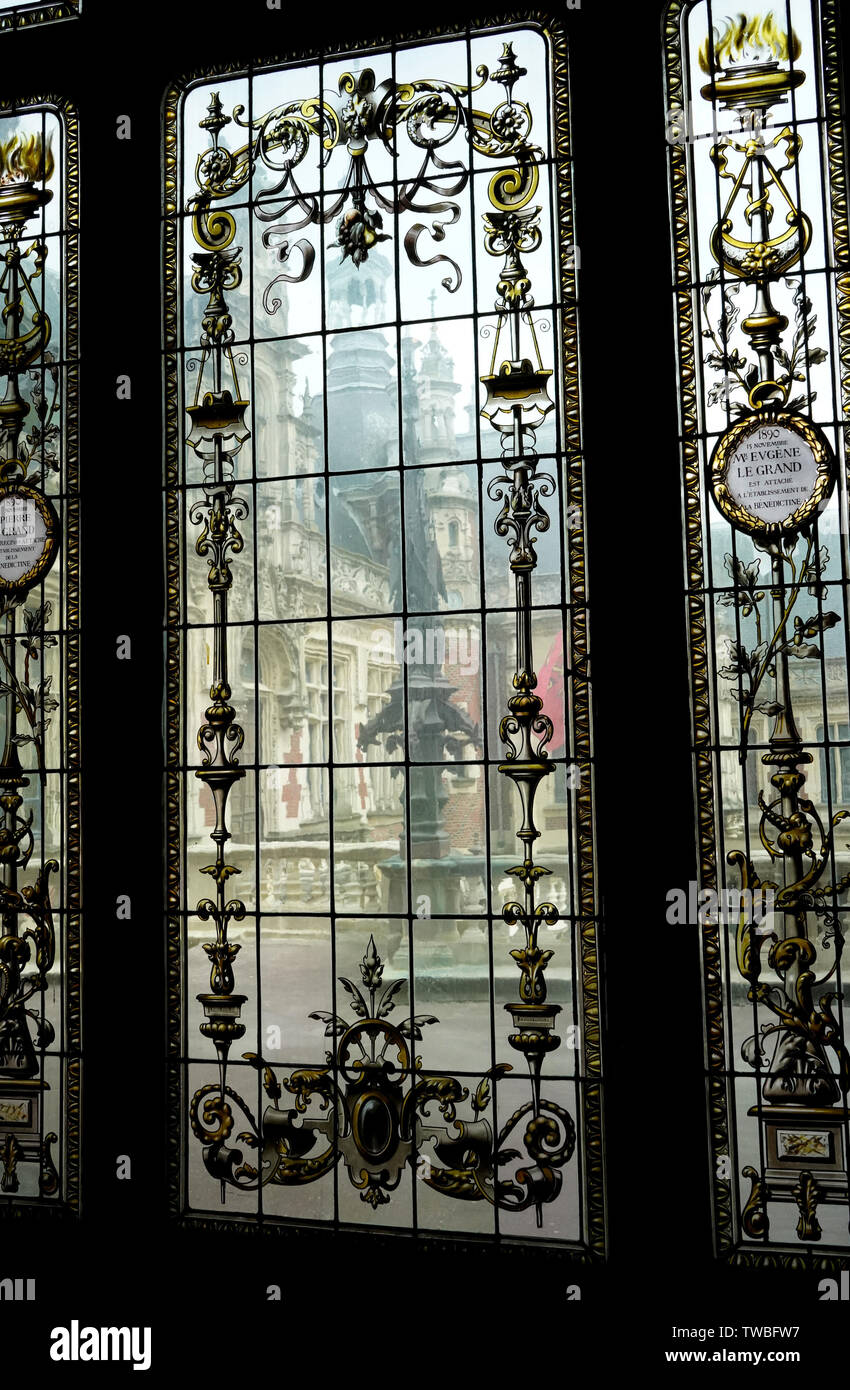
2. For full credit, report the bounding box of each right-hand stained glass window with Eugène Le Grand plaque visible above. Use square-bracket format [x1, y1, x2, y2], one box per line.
[667, 0, 850, 1264]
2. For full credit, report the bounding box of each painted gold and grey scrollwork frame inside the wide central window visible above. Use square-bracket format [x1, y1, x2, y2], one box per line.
[188, 42, 576, 1225]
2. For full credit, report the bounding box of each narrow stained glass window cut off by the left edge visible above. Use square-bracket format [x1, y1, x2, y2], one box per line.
[0, 101, 81, 1208]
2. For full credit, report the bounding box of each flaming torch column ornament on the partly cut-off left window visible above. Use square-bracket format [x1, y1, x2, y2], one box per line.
[0, 132, 61, 1195]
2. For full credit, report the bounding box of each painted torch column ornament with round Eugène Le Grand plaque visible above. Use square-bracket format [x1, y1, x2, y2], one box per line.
[699, 15, 850, 1241]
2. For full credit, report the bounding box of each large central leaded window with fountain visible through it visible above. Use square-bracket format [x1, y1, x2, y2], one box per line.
[164, 16, 604, 1254]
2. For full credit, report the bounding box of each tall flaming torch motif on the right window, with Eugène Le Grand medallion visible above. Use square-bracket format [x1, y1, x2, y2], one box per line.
[699, 14, 850, 1241]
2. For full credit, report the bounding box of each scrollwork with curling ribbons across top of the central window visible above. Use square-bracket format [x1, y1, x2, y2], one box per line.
[189, 43, 542, 304]
